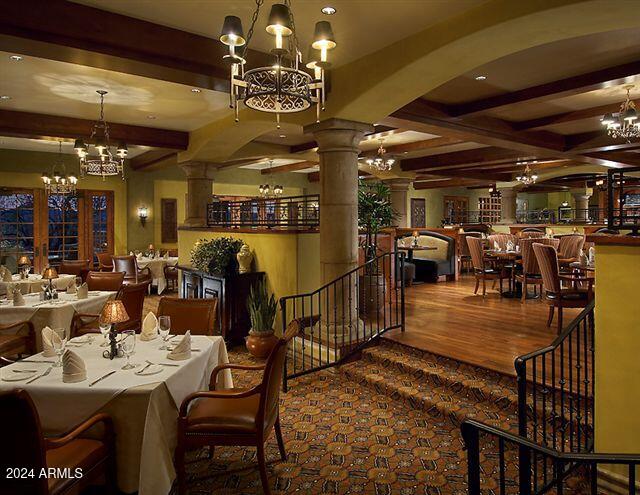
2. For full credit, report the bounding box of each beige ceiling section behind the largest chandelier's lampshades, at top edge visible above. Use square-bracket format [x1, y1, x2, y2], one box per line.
[70, 0, 484, 67]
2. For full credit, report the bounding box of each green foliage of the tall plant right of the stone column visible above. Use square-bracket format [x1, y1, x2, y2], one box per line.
[358, 180, 397, 261]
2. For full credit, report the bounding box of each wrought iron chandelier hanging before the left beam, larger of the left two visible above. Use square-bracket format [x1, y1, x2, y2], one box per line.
[73, 89, 129, 180]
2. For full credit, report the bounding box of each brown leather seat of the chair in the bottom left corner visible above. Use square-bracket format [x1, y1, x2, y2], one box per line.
[47, 438, 109, 494]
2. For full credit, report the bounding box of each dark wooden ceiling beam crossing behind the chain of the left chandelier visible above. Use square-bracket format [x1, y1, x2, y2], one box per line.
[0, 110, 189, 150]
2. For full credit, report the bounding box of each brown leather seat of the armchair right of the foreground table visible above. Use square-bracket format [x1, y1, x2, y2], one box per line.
[187, 388, 260, 434]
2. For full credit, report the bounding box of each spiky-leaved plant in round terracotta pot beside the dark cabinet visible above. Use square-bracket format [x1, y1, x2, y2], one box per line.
[246, 279, 278, 358]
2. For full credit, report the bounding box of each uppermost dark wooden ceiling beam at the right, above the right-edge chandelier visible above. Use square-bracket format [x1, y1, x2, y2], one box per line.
[450, 61, 640, 116]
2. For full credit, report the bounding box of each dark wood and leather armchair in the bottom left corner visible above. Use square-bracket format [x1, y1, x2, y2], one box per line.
[0, 389, 116, 495]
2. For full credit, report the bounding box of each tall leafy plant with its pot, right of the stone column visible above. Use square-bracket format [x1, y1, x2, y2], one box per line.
[358, 180, 396, 317]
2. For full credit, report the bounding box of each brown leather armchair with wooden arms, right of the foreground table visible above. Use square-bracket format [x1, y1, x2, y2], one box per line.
[175, 320, 300, 495]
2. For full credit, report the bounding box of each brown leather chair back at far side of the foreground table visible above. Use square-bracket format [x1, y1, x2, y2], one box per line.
[157, 297, 218, 335]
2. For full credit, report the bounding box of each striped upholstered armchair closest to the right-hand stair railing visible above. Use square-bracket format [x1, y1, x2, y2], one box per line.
[533, 243, 592, 333]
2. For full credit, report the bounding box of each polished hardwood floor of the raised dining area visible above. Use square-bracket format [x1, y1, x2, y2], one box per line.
[385, 275, 580, 375]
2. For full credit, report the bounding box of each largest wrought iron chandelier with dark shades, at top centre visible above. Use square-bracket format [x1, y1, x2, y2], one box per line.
[220, 0, 336, 128]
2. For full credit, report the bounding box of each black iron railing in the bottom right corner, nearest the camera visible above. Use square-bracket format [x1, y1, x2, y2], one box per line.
[461, 420, 640, 495]
